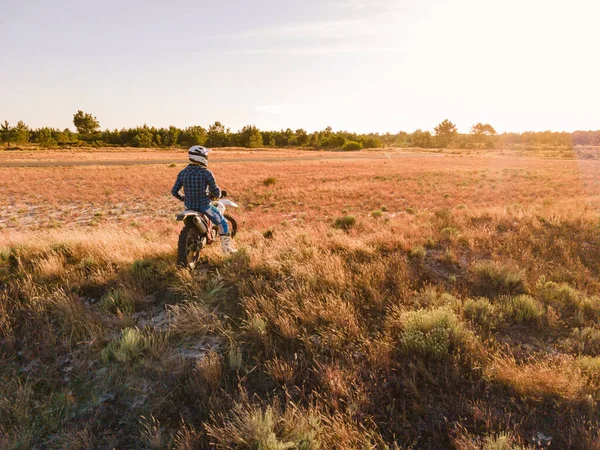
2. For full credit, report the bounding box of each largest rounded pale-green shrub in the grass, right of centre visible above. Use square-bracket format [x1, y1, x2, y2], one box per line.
[399, 308, 469, 359]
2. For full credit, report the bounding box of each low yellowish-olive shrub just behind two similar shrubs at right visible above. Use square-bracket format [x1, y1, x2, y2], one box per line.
[471, 261, 526, 296]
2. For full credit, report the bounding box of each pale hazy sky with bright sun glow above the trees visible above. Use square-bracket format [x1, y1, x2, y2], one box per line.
[0, 0, 600, 133]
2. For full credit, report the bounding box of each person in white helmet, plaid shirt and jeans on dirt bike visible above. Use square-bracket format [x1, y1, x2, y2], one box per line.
[171, 145, 237, 254]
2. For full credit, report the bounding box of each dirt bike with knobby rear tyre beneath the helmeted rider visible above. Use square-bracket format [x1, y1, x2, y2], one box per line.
[176, 198, 238, 269]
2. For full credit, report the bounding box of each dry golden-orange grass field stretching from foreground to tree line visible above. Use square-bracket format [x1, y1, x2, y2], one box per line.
[0, 150, 600, 450]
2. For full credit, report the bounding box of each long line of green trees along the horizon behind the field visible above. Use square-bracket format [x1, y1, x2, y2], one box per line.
[0, 111, 600, 150]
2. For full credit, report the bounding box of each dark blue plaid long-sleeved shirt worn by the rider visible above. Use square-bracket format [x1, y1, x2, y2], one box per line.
[171, 164, 221, 211]
